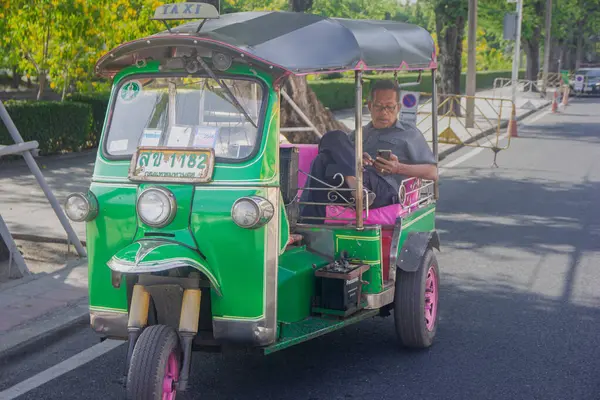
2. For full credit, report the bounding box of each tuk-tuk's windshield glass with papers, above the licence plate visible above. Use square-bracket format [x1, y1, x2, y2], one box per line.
[105, 77, 263, 161]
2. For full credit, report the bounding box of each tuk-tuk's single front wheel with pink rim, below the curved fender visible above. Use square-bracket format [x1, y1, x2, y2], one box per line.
[127, 325, 181, 400]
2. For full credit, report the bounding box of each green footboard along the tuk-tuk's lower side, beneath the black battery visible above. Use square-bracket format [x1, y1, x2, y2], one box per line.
[263, 310, 379, 354]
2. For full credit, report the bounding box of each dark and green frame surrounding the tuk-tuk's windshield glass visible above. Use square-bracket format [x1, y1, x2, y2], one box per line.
[101, 71, 270, 164]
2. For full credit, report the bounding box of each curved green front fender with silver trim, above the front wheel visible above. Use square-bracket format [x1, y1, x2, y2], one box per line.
[107, 240, 221, 296]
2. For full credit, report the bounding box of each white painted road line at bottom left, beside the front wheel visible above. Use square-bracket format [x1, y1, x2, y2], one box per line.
[0, 339, 125, 400]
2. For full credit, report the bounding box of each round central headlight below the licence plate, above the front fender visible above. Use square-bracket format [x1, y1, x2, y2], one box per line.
[136, 187, 177, 228]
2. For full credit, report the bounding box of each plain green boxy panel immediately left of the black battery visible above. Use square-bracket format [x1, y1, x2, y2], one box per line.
[277, 247, 328, 323]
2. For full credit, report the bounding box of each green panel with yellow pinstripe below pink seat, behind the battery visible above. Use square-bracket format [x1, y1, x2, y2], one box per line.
[333, 229, 383, 294]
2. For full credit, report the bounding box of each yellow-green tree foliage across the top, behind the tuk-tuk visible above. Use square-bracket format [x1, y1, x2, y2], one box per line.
[0, 0, 600, 96]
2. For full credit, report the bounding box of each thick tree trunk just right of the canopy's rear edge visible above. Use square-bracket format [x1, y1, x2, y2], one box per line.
[435, 12, 467, 117]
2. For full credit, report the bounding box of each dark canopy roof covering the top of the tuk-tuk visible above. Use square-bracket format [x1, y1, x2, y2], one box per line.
[96, 11, 436, 75]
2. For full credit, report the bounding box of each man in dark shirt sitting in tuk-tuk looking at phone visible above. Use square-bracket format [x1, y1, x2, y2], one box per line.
[302, 80, 438, 222]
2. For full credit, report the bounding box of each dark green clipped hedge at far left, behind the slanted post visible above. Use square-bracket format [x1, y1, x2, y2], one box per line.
[0, 101, 96, 155]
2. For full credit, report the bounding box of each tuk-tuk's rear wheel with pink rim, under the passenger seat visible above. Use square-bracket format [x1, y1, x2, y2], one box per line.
[394, 248, 440, 348]
